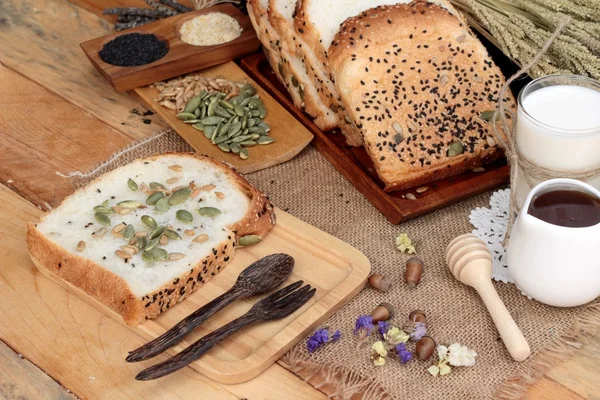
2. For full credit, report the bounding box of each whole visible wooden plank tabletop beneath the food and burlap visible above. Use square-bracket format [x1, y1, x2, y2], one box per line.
[0, 0, 600, 399]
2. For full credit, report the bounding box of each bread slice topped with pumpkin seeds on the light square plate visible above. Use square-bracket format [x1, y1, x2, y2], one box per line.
[27, 154, 275, 325]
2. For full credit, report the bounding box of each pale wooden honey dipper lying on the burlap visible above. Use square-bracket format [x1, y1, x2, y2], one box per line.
[446, 233, 531, 361]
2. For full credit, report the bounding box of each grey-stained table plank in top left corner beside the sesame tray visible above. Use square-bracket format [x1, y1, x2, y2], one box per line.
[0, 0, 167, 139]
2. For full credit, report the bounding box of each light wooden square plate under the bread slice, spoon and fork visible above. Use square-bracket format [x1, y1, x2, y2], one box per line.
[33, 210, 371, 384]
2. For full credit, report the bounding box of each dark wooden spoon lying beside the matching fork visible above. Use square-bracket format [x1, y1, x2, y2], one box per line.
[125, 253, 294, 362]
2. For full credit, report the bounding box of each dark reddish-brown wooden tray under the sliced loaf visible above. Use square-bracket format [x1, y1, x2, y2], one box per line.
[241, 52, 510, 224]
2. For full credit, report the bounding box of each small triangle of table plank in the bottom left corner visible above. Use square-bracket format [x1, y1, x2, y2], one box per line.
[0, 342, 75, 400]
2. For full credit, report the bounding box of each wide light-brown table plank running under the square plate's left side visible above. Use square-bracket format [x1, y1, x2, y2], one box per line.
[0, 185, 324, 400]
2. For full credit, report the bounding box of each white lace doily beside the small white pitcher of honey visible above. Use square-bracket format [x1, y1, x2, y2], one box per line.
[469, 189, 514, 283]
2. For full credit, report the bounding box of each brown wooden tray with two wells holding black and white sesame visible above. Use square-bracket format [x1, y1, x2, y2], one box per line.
[81, 4, 260, 92]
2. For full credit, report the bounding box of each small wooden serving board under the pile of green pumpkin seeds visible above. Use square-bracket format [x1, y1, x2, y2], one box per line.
[135, 62, 313, 173]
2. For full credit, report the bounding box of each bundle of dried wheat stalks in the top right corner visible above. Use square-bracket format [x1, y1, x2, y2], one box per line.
[451, 0, 600, 79]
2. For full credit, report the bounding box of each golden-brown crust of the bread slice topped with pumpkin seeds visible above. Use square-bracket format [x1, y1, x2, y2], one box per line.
[27, 153, 275, 325]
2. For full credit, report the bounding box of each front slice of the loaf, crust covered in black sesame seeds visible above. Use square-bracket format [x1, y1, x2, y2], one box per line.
[328, 0, 514, 191]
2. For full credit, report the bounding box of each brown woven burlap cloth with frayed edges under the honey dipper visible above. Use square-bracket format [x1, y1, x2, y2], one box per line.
[75, 132, 600, 400]
